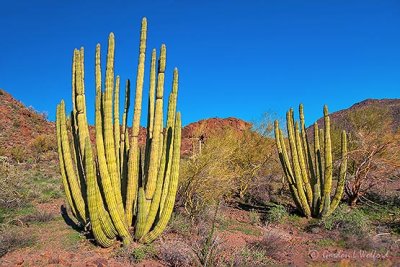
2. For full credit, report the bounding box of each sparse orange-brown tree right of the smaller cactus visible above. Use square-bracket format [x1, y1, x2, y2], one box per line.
[345, 106, 400, 206]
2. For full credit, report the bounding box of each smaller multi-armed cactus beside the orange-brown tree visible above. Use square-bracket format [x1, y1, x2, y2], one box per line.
[275, 105, 347, 218]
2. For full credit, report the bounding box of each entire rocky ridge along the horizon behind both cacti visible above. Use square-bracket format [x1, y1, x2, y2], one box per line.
[0, 89, 400, 158]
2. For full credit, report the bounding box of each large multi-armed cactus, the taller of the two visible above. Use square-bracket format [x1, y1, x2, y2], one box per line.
[57, 18, 181, 247]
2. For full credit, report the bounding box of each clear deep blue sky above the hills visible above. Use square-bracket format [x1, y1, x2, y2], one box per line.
[0, 0, 400, 124]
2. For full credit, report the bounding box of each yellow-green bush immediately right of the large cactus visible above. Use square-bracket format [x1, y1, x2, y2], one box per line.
[178, 131, 239, 217]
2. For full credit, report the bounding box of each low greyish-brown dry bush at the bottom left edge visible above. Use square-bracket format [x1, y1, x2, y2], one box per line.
[0, 229, 36, 258]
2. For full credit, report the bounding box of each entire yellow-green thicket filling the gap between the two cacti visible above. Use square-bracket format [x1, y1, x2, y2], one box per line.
[178, 115, 280, 220]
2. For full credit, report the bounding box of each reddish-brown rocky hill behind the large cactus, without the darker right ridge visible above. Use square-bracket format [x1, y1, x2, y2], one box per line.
[0, 89, 250, 160]
